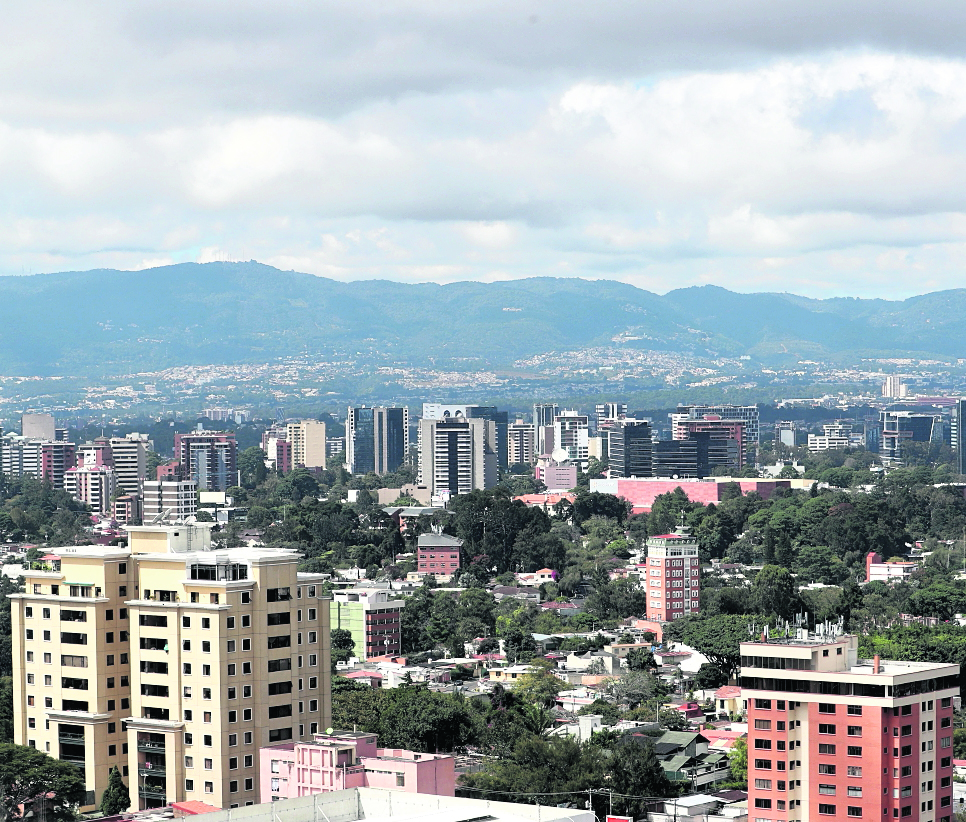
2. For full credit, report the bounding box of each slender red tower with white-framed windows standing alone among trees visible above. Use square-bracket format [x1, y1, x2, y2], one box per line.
[647, 525, 701, 622]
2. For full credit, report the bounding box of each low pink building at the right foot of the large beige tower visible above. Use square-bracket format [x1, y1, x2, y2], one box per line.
[258, 731, 456, 802]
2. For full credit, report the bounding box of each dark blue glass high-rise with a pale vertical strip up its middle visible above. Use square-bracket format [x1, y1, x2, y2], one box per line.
[345, 406, 409, 474]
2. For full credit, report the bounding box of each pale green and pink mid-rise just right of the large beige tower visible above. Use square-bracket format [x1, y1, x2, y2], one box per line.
[329, 588, 406, 659]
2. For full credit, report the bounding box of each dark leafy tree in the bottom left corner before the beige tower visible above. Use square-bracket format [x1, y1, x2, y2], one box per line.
[0, 744, 87, 822]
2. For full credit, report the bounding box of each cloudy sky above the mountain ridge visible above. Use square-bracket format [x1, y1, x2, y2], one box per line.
[0, 0, 966, 299]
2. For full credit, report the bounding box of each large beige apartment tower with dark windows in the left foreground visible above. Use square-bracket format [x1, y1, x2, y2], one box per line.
[11, 523, 331, 811]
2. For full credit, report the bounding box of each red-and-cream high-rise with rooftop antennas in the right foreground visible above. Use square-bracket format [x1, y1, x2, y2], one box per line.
[740, 626, 959, 822]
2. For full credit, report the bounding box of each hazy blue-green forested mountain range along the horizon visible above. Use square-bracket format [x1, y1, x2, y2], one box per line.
[0, 262, 966, 374]
